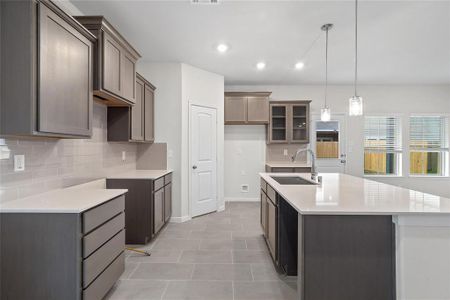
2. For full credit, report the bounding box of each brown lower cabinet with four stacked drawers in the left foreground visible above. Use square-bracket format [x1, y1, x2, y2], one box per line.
[0, 196, 125, 300]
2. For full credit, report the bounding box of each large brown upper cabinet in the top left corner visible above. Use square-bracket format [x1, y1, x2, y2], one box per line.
[0, 0, 95, 138]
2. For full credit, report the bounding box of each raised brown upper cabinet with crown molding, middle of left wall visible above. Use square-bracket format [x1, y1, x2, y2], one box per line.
[75, 16, 141, 106]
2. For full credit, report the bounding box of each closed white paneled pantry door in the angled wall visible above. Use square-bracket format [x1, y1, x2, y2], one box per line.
[190, 105, 217, 217]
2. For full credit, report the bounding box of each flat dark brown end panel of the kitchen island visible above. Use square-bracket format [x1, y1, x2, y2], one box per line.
[299, 215, 396, 300]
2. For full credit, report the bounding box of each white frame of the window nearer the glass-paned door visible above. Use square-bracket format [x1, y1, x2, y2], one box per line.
[362, 113, 405, 178]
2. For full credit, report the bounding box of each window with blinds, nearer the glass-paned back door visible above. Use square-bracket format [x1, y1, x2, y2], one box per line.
[364, 116, 402, 176]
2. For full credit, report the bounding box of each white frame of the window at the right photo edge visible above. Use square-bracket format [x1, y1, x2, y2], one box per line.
[405, 113, 450, 178]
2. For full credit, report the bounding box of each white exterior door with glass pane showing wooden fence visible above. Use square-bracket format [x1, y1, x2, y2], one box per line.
[311, 114, 347, 173]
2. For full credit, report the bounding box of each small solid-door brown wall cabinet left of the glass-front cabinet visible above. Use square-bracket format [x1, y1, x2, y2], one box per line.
[224, 92, 271, 125]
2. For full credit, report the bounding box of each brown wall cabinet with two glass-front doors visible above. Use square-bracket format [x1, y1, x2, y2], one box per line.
[268, 101, 310, 144]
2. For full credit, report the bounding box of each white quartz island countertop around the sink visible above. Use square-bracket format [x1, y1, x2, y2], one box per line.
[260, 173, 450, 215]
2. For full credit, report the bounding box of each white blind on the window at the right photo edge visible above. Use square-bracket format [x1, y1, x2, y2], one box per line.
[409, 116, 448, 151]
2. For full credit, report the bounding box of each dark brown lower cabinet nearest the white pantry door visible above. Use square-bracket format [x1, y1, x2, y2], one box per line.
[106, 173, 172, 244]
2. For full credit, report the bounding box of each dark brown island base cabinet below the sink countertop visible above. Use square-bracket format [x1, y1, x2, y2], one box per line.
[261, 180, 396, 300]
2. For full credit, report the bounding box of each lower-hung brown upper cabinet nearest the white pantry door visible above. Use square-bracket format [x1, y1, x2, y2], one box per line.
[107, 74, 155, 143]
